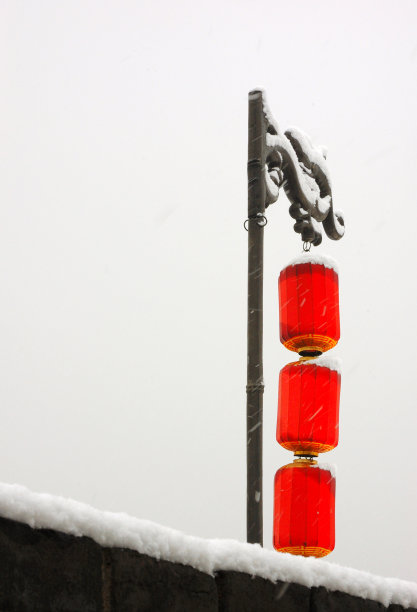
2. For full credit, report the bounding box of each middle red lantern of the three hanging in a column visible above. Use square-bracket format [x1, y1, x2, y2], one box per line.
[277, 357, 340, 455]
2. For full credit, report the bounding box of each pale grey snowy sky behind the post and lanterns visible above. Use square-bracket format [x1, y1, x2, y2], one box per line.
[0, 0, 417, 580]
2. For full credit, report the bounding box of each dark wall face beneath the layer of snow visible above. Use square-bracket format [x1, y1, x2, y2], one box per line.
[0, 518, 417, 612]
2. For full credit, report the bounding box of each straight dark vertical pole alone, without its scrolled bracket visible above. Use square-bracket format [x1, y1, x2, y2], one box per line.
[246, 91, 265, 546]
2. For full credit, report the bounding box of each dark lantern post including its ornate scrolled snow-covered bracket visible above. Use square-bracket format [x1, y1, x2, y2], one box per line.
[245, 90, 344, 546]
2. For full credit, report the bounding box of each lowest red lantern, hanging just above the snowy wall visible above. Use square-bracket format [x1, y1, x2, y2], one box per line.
[274, 459, 336, 557]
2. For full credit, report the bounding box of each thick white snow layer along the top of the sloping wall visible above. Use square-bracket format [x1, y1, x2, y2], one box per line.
[0, 483, 417, 608]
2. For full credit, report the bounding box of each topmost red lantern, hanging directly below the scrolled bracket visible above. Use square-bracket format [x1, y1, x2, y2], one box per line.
[279, 256, 340, 354]
